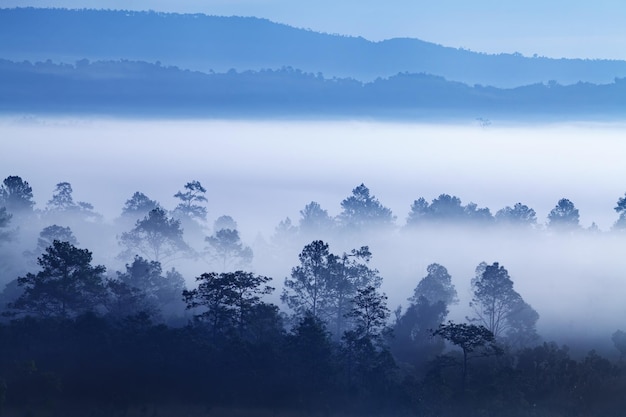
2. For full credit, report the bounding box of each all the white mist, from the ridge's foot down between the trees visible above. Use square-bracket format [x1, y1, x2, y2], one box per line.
[0, 118, 626, 352]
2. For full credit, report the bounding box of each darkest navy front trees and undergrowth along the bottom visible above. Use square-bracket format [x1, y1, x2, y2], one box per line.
[0, 234, 626, 416]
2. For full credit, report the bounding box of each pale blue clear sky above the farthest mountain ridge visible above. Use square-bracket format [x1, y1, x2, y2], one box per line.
[2, 0, 626, 60]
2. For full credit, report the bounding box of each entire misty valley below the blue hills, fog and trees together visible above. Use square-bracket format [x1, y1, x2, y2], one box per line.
[0, 116, 626, 417]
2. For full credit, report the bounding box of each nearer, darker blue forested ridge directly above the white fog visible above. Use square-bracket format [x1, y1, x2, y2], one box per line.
[0, 60, 626, 119]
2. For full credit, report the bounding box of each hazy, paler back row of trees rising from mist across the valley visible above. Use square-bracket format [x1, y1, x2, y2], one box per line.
[0, 176, 626, 281]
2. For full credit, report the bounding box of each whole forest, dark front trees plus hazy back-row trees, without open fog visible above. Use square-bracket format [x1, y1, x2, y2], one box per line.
[0, 175, 626, 417]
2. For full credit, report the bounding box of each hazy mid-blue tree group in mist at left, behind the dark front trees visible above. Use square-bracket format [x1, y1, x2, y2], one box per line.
[0, 176, 253, 279]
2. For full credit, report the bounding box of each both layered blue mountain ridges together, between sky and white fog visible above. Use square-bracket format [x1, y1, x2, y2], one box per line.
[0, 8, 626, 120]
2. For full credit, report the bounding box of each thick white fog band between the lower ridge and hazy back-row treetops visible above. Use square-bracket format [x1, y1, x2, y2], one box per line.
[0, 118, 626, 235]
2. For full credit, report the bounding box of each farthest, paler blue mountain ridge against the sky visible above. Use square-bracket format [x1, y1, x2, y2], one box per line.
[0, 8, 626, 87]
